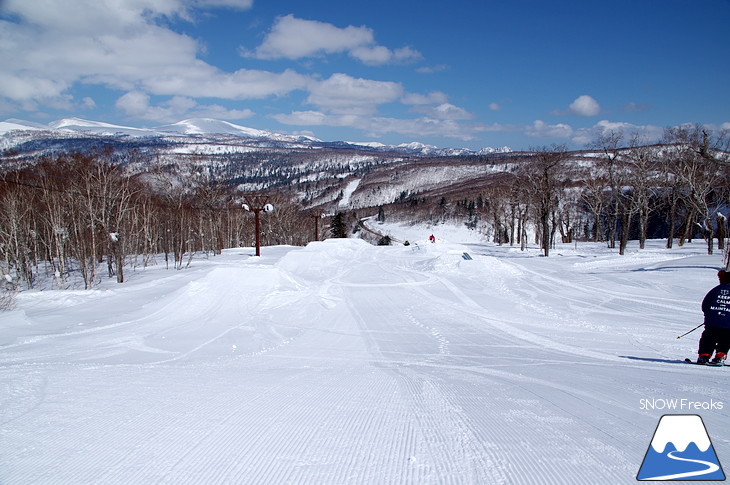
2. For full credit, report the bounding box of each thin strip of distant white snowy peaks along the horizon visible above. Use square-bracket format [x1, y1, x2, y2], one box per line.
[0, 118, 512, 156]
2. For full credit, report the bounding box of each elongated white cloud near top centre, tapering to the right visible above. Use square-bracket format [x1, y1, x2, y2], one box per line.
[242, 14, 421, 65]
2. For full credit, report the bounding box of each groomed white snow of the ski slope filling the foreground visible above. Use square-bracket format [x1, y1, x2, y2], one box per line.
[0, 230, 730, 485]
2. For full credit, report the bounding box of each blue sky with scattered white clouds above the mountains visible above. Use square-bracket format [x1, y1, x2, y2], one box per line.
[0, 0, 730, 149]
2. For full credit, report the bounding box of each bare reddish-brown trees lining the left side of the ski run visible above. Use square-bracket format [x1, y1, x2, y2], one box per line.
[0, 151, 312, 288]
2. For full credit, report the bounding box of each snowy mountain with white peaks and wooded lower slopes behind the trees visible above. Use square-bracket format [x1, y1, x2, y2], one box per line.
[0, 118, 519, 210]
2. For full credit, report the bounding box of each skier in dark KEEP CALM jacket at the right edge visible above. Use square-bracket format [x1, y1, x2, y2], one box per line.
[697, 270, 730, 365]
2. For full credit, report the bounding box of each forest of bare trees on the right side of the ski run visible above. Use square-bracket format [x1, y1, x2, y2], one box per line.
[390, 126, 730, 265]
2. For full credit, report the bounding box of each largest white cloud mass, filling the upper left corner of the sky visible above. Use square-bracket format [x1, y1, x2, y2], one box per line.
[0, 0, 302, 114]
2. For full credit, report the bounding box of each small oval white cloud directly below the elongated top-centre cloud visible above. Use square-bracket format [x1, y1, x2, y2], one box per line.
[306, 73, 403, 115]
